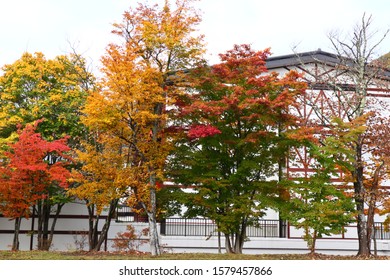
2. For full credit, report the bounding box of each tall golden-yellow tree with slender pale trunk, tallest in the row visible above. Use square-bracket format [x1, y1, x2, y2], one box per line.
[70, 0, 204, 254]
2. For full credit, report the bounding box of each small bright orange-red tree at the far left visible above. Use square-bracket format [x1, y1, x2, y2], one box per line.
[0, 122, 70, 250]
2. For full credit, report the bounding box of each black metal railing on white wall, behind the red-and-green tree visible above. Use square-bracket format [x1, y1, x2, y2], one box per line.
[161, 218, 287, 237]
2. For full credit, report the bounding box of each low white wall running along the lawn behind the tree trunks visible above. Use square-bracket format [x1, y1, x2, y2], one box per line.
[0, 221, 390, 255]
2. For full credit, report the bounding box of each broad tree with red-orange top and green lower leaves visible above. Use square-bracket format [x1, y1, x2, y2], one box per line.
[169, 45, 305, 253]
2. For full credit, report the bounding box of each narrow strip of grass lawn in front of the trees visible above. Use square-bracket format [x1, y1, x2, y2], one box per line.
[0, 251, 390, 260]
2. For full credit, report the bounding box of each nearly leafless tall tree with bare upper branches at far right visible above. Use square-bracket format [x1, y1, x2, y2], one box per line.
[320, 14, 389, 256]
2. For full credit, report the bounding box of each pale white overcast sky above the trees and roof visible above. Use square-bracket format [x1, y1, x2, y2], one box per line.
[0, 0, 390, 72]
